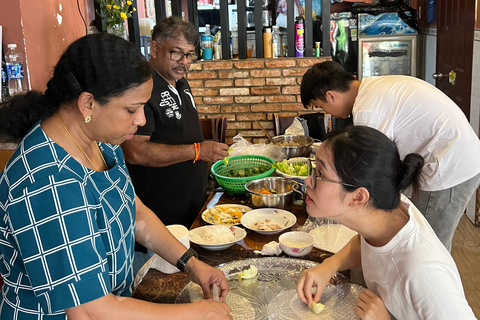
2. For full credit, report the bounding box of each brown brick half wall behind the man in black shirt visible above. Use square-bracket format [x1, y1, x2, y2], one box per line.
[187, 57, 330, 144]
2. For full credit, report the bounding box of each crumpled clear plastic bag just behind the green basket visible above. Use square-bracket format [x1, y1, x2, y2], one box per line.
[230, 134, 287, 161]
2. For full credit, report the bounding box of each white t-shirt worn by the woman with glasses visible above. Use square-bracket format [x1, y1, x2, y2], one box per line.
[361, 195, 476, 320]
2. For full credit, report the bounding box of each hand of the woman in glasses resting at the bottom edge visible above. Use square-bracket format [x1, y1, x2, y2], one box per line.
[355, 289, 391, 320]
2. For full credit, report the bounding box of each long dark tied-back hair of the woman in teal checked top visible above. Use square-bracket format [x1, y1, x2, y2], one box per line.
[0, 33, 152, 141]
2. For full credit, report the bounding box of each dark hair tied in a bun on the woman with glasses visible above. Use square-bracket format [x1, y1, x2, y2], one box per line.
[324, 126, 424, 211]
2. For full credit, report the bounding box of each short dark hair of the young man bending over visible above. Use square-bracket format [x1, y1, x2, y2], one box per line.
[300, 61, 355, 108]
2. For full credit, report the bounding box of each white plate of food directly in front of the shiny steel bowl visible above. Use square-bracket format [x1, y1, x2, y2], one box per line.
[242, 208, 297, 234]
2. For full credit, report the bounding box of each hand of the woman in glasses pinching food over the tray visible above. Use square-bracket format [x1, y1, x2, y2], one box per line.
[297, 263, 336, 306]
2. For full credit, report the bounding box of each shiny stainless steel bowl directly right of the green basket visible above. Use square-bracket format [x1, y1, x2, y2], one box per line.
[245, 177, 296, 210]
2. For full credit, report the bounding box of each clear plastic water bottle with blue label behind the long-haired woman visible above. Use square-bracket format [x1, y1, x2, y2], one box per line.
[5, 43, 27, 96]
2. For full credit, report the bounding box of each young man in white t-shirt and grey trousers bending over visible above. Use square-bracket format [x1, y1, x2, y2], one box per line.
[300, 61, 480, 251]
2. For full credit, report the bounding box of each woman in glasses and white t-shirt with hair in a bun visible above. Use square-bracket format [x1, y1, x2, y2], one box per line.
[297, 126, 476, 320]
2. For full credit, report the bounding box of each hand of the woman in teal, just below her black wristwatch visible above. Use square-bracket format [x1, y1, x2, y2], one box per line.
[185, 258, 228, 301]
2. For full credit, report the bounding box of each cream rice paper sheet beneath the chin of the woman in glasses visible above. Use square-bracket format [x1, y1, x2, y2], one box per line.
[309, 223, 357, 253]
